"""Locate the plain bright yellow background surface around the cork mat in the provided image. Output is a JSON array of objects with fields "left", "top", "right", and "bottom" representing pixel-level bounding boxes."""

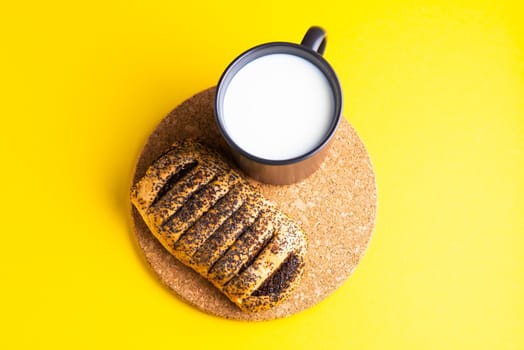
[{"left": 0, "top": 0, "right": 524, "bottom": 349}]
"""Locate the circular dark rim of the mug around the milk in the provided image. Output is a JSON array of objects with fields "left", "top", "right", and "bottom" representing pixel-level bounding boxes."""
[{"left": 214, "top": 41, "right": 343, "bottom": 165}]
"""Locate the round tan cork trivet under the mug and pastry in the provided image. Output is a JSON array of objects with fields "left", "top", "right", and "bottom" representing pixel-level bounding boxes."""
[{"left": 132, "top": 88, "right": 377, "bottom": 321}]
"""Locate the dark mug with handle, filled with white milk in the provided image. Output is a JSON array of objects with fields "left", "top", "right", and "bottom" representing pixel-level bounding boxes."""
[{"left": 215, "top": 27, "right": 342, "bottom": 185}]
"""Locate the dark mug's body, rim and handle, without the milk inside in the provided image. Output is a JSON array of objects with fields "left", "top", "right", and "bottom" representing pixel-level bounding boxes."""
[{"left": 215, "top": 27, "right": 342, "bottom": 185}]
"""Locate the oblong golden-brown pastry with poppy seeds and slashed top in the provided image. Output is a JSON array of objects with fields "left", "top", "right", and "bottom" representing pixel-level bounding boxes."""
[{"left": 131, "top": 140, "right": 306, "bottom": 312}]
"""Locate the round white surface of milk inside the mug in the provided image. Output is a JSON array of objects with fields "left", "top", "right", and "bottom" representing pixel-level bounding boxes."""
[{"left": 223, "top": 54, "right": 335, "bottom": 160}]
